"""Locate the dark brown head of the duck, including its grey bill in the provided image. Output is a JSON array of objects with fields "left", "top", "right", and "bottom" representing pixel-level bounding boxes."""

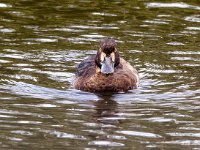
[{"left": 95, "top": 37, "right": 120, "bottom": 75}]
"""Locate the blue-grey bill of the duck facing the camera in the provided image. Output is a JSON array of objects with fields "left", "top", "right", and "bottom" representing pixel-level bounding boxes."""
[{"left": 101, "top": 57, "right": 114, "bottom": 74}]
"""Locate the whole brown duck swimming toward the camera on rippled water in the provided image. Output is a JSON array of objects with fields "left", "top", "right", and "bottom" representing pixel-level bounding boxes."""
[{"left": 73, "top": 37, "right": 139, "bottom": 92}]
